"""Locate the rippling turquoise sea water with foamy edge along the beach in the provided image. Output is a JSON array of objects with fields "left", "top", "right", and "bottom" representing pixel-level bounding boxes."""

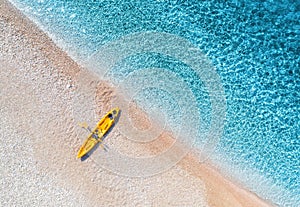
[{"left": 10, "top": 0, "right": 300, "bottom": 206}]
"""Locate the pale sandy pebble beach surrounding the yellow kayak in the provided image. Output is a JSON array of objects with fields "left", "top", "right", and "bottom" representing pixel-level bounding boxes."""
[{"left": 0, "top": 0, "right": 273, "bottom": 207}]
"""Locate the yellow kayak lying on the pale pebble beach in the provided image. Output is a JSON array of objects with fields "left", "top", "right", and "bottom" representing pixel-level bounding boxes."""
[{"left": 77, "top": 108, "right": 120, "bottom": 158}]
